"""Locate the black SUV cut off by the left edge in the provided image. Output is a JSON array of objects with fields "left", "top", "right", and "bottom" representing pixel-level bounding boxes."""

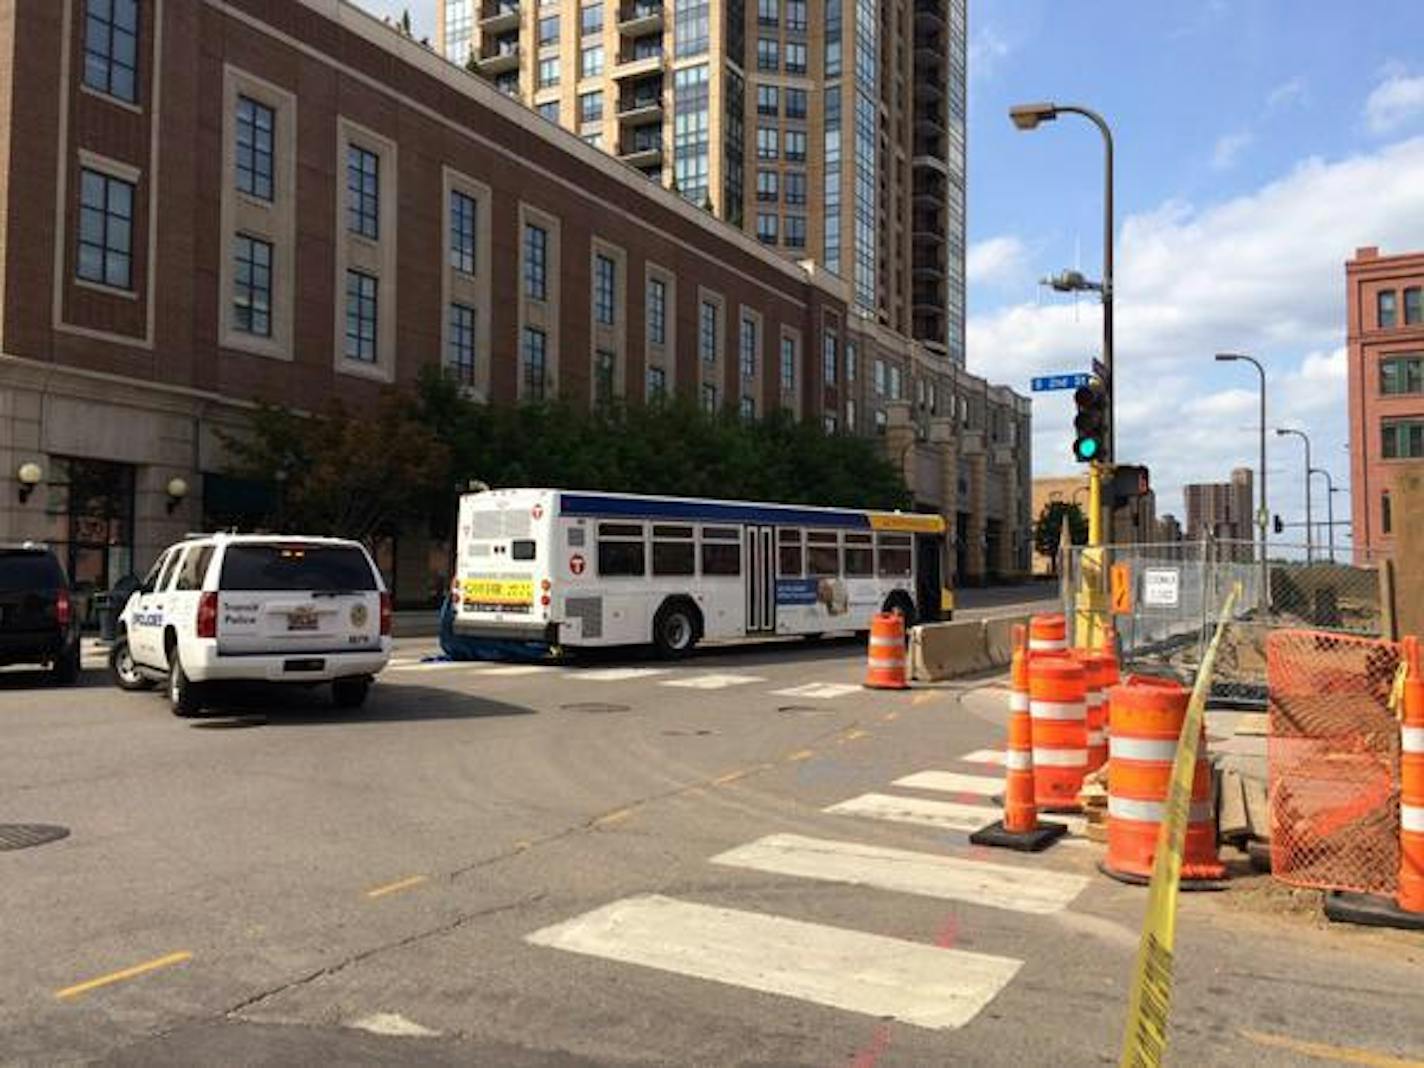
[{"left": 0, "top": 544, "right": 80, "bottom": 684}]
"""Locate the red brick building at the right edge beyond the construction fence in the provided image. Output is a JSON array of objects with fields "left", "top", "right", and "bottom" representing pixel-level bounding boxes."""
[{"left": 1344, "top": 248, "right": 1424, "bottom": 562}]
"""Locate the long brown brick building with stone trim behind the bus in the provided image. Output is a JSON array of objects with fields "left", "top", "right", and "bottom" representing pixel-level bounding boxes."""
[{"left": 0, "top": 0, "right": 1030, "bottom": 601}]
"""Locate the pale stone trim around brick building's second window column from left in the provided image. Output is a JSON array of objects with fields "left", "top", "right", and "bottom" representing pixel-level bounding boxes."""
[{"left": 218, "top": 64, "right": 293, "bottom": 360}]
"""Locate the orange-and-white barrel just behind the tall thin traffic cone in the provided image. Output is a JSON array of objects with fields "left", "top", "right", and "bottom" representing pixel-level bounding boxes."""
[{"left": 1028, "top": 657, "right": 1088, "bottom": 812}]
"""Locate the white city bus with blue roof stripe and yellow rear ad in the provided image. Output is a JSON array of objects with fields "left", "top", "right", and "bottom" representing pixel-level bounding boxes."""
[{"left": 450, "top": 490, "right": 948, "bottom": 656}]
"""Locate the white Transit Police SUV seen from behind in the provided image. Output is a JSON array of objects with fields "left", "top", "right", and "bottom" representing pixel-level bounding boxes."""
[{"left": 110, "top": 534, "right": 390, "bottom": 716}]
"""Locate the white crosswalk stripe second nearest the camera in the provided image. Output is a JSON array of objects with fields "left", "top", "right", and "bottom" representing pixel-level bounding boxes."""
[{"left": 712, "top": 834, "right": 1088, "bottom": 914}]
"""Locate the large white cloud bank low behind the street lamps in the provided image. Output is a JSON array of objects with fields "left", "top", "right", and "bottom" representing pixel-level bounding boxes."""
[{"left": 968, "top": 137, "right": 1424, "bottom": 532}]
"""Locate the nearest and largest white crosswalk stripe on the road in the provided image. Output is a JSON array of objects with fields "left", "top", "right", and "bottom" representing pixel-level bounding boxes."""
[{"left": 525, "top": 894, "right": 1022, "bottom": 1028}]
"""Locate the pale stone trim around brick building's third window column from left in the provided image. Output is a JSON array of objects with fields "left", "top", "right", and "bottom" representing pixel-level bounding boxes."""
[{"left": 332, "top": 112, "right": 395, "bottom": 383}]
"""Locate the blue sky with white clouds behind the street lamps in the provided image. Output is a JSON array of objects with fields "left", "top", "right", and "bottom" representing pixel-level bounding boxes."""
[{"left": 362, "top": 0, "right": 1424, "bottom": 546}]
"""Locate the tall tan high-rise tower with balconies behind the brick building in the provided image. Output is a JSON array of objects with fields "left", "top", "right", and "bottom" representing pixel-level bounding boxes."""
[{"left": 437, "top": 0, "right": 967, "bottom": 365}]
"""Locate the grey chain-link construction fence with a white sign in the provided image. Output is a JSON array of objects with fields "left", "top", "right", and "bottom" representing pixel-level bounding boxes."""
[{"left": 1061, "top": 538, "right": 1384, "bottom": 708}]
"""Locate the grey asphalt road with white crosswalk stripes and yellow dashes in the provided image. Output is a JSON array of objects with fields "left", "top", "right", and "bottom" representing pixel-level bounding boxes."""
[{"left": 0, "top": 641, "right": 1424, "bottom": 1068}]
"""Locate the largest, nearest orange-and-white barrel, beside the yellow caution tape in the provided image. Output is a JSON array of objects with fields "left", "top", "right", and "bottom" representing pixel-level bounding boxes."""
[{"left": 1101, "top": 675, "right": 1226, "bottom": 890}]
